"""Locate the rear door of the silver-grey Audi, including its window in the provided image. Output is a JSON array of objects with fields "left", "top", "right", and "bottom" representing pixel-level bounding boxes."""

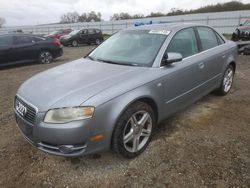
[{"left": 196, "top": 26, "right": 226, "bottom": 92}]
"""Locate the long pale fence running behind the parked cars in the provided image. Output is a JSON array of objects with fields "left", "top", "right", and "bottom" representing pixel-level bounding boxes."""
[{"left": 0, "top": 10, "right": 250, "bottom": 34}]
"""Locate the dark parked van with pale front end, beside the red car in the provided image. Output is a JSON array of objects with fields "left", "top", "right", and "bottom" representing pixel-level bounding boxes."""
[{"left": 60, "top": 29, "right": 103, "bottom": 47}]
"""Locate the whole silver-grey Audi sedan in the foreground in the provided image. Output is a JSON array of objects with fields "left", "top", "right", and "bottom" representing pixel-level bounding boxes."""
[{"left": 14, "top": 23, "right": 238, "bottom": 158}]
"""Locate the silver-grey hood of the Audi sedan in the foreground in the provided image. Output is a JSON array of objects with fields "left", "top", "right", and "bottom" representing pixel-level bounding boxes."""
[{"left": 17, "top": 59, "right": 145, "bottom": 112}]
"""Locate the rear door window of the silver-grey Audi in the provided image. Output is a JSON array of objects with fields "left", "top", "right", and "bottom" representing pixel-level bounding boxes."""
[{"left": 197, "top": 27, "right": 218, "bottom": 51}]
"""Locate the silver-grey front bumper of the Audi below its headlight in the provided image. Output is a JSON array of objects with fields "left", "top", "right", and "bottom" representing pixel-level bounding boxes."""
[{"left": 15, "top": 111, "right": 91, "bottom": 157}]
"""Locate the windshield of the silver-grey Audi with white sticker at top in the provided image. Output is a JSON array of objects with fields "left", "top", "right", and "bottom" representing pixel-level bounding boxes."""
[{"left": 88, "top": 30, "right": 169, "bottom": 66}]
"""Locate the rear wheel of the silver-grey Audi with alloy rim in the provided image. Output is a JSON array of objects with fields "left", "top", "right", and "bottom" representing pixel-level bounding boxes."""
[{"left": 215, "top": 65, "right": 235, "bottom": 96}]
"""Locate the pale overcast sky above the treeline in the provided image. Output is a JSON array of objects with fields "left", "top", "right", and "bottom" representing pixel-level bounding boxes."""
[{"left": 0, "top": 0, "right": 250, "bottom": 26}]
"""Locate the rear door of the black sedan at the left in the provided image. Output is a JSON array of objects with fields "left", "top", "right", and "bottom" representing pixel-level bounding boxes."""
[{"left": 11, "top": 35, "right": 36, "bottom": 61}]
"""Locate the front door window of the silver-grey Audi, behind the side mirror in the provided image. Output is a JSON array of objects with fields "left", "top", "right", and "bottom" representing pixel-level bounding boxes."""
[{"left": 166, "top": 28, "right": 198, "bottom": 58}]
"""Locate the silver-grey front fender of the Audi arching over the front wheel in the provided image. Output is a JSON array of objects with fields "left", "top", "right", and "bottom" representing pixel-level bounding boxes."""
[{"left": 83, "top": 80, "right": 164, "bottom": 146}]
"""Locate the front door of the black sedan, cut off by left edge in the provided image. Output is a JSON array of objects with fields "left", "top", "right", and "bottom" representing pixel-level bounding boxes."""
[{"left": 0, "top": 35, "right": 13, "bottom": 64}]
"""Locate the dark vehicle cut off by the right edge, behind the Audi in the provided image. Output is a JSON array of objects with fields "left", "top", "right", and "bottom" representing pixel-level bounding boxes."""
[{"left": 232, "top": 18, "right": 250, "bottom": 41}]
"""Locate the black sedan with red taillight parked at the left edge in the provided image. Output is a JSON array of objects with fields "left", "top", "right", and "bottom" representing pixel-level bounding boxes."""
[{"left": 0, "top": 34, "right": 63, "bottom": 66}]
